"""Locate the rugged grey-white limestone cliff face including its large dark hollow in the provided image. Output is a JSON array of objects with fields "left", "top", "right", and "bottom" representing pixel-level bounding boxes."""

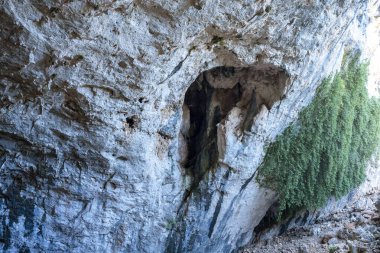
[{"left": 0, "top": 0, "right": 376, "bottom": 252}]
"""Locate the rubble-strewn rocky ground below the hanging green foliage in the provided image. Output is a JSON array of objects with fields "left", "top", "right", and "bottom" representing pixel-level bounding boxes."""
[{"left": 242, "top": 192, "right": 380, "bottom": 253}]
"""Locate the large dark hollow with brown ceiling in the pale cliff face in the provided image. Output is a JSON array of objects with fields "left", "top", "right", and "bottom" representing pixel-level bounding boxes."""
[{"left": 179, "top": 64, "right": 289, "bottom": 187}]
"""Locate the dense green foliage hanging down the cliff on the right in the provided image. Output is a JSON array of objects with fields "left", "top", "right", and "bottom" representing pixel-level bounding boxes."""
[{"left": 258, "top": 54, "right": 380, "bottom": 217}]
